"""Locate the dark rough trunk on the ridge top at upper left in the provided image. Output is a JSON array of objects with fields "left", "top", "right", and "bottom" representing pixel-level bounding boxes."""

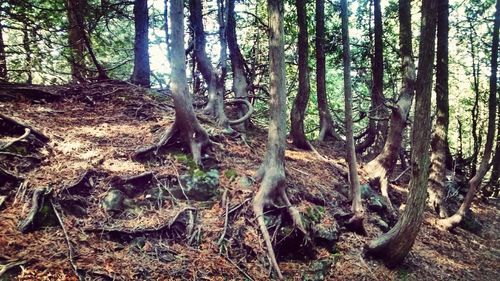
[{"left": 66, "top": 0, "right": 87, "bottom": 82}]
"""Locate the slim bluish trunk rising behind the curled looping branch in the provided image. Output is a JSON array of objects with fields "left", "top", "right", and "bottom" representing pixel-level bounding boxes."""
[{"left": 226, "top": 0, "right": 248, "bottom": 131}]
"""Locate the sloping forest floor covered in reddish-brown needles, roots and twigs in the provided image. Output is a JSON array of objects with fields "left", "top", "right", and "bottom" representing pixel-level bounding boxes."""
[{"left": 0, "top": 82, "right": 500, "bottom": 280}]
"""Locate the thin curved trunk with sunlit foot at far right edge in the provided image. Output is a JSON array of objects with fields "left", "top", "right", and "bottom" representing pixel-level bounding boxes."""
[{"left": 438, "top": 0, "right": 500, "bottom": 229}]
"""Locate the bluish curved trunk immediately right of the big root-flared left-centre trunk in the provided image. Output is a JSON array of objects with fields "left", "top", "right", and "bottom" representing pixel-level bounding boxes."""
[{"left": 189, "top": 0, "right": 230, "bottom": 128}]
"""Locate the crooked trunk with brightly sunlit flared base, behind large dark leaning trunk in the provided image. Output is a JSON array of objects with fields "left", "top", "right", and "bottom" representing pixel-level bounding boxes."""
[{"left": 365, "top": 1, "right": 415, "bottom": 210}]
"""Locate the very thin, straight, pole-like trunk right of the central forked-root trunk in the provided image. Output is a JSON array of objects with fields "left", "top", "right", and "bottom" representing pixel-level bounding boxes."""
[{"left": 340, "top": 0, "right": 364, "bottom": 232}]
